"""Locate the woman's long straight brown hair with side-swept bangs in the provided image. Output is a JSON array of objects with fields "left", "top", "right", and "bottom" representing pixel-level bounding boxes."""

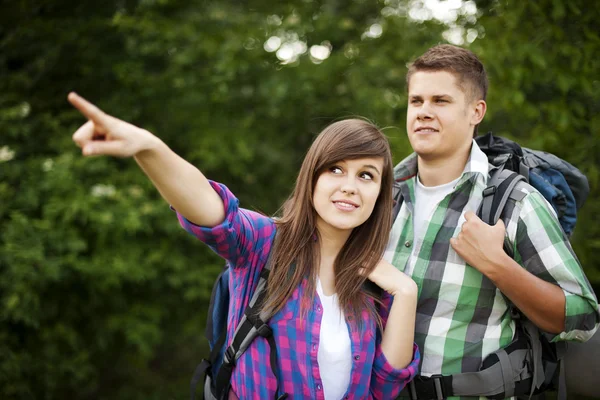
[{"left": 264, "top": 119, "right": 393, "bottom": 321}]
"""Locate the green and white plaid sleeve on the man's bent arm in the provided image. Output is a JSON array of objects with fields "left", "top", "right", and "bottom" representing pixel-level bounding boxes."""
[{"left": 514, "top": 192, "right": 600, "bottom": 341}]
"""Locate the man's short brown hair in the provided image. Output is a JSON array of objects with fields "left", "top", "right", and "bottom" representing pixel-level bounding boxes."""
[{"left": 406, "top": 44, "right": 488, "bottom": 102}]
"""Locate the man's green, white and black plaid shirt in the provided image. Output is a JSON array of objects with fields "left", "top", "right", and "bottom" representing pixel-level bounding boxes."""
[{"left": 385, "top": 142, "right": 600, "bottom": 399}]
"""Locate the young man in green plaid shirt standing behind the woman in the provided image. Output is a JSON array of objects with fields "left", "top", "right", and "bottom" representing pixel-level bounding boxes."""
[{"left": 386, "top": 45, "right": 600, "bottom": 399}]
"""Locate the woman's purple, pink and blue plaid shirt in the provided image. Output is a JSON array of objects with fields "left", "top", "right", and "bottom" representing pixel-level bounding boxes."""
[{"left": 178, "top": 182, "right": 419, "bottom": 399}]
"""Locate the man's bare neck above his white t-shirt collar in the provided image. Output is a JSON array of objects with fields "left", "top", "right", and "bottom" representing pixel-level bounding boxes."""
[{"left": 417, "top": 146, "right": 471, "bottom": 186}]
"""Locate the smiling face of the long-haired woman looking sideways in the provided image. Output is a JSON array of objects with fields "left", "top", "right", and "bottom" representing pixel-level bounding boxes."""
[{"left": 313, "top": 157, "right": 383, "bottom": 238}]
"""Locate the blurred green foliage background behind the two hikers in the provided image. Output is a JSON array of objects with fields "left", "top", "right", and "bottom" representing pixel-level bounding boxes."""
[{"left": 0, "top": 0, "right": 600, "bottom": 399}]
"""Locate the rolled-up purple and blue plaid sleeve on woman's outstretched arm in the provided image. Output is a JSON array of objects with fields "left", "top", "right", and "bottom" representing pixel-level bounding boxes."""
[{"left": 175, "top": 181, "right": 275, "bottom": 267}]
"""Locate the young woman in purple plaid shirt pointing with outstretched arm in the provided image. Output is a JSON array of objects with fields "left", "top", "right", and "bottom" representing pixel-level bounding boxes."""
[{"left": 68, "top": 93, "right": 419, "bottom": 399}]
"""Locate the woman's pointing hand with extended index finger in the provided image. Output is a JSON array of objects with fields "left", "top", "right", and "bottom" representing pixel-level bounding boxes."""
[{"left": 68, "top": 92, "right": 160, "bottom": 157}]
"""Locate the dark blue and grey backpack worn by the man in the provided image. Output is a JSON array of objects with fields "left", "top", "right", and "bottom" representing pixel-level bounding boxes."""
[{"left": 475, "top": 132, "right": 600, "bottom": 398}]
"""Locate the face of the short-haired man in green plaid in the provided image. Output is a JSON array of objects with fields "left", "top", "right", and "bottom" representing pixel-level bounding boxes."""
[{"left": 406, "top": 71, "right": 485, "bottom": 162}]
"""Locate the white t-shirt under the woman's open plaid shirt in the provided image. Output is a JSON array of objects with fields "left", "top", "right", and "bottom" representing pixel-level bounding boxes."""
[{"left": 317, "top": 279, "right": 352, "bottom": 400}]
